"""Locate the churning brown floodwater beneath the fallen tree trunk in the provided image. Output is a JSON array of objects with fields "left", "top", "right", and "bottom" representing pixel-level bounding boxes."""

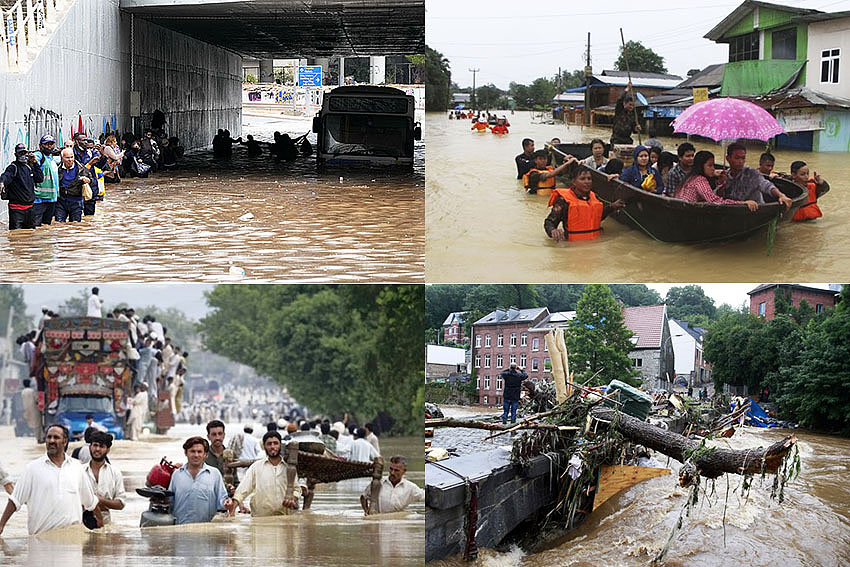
[{"left": 432, "top": 429, "right": 850, "bottom": 567}]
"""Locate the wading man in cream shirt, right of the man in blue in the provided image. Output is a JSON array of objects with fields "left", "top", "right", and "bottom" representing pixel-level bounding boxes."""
[{"left": 230, "top": 431, "right": 300, "bottom": 517}]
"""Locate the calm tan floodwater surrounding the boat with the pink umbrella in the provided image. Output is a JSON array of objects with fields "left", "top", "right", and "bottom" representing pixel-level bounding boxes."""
[{"left": 425, "top": 112, "right": 850, "bottom": 283}]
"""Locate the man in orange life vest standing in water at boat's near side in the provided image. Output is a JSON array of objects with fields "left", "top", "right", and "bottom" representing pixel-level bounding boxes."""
[{"left": 543, "top": 166, "right": 626, "bottom": 242}]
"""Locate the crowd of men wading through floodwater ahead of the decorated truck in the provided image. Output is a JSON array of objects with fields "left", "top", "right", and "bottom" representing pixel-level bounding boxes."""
[{"left": 0, "top": 412, "right": 425, "bottom": 536}]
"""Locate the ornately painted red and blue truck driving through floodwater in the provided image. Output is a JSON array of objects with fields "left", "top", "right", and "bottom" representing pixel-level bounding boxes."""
[{"left": 37, "top": 317, "right": 132, "bottom": 439}]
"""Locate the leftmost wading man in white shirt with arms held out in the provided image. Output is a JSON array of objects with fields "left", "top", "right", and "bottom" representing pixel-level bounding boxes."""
[{"left": 0, "top": 425, "right": 102, "bottom": 535}]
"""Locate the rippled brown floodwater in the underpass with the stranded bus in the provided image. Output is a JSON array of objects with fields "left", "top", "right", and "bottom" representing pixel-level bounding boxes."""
[{"left": 0, "top": 115, "right": 425, "bottom": 283}]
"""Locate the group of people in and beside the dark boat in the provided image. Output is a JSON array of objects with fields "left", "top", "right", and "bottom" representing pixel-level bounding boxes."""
[{"left": 515, "top": 133, "right": 829, "bottom": 241}]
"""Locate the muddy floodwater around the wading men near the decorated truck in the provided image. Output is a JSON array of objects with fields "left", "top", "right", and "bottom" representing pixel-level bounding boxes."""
[{"left": 0, "top": 424, "right": 425, "bottom": 567}]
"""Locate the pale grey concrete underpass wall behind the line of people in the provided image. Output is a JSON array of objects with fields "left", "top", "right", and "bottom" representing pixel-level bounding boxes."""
[{"left": 0, "top": 0, "right": 242, "bottom": 168}]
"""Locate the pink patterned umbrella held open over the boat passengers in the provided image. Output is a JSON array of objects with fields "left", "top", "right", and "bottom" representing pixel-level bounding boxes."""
[{"left": 673, "top": 97, "right": 785, "bottom": 142}]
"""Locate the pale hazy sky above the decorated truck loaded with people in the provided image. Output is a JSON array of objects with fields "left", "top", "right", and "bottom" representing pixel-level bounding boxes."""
[{"left": 22, "top": 284, "right": 215, "bottom": 320}]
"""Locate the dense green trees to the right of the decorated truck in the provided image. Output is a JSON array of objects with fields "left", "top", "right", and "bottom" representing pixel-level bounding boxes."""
[{"left": 201, "top": 285, "right": 425, "bottom": 433}]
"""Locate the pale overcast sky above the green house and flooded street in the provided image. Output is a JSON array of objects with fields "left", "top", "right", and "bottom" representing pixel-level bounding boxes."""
[{"left": 425, "top": 0, "right": 850, "bottom": 89}]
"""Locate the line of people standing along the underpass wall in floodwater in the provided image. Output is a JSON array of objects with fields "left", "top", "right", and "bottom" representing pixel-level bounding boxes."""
[{"left": 0, "top": 127, "right": 183, "bottom": 230}]
